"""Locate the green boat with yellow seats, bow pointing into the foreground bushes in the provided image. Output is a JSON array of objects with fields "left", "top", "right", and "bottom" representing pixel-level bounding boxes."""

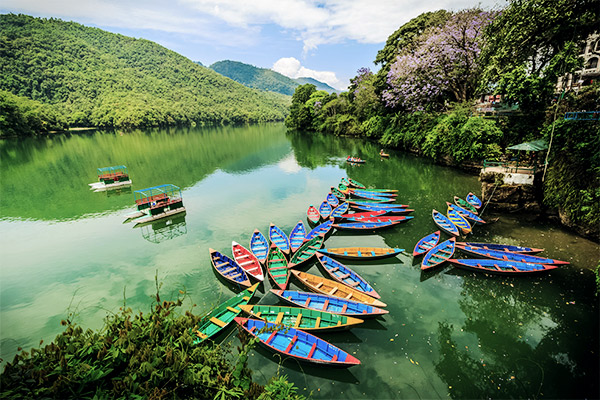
[{"left": 192, "top": 283, "right": 259, "bottom": 344}]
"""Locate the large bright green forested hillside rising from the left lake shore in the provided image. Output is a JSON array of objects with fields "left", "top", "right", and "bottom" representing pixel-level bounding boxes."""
[{"left": 0, "top": 14, "right": 289, "bottom": 133}]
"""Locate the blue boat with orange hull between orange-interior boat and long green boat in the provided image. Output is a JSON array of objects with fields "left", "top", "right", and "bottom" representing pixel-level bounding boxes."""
[{"left": 271, "top": 289, "right": 389, "bottom": 318}]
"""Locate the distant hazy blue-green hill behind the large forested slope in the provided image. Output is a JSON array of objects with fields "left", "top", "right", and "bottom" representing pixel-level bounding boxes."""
[{"left": 210, "top": 60, "right": 338, "bottom": 96}]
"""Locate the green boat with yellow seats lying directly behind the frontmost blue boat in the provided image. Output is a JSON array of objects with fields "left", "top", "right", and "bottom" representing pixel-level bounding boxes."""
[{"left": 240, "top": 304, "right": 364, "bottom": 332}]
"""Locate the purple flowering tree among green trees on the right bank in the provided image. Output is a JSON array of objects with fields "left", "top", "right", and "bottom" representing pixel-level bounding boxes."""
[{"left": 382, "top": 9, "right": 495, "bottom": 111}]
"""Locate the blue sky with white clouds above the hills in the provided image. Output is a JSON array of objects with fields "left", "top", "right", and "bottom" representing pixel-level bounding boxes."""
[{"left": 0, "top": 0, "right": 506, "bottom": 90}]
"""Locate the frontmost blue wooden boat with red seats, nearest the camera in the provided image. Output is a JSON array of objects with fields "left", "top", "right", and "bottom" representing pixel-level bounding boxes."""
[{"left": 235, "top": 317, "right": 360, "bottom": 367}]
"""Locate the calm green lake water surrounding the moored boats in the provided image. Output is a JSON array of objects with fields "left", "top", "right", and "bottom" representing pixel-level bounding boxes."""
[{"left": 0, "top": 124, "right": 600, "bottom": 399}]
